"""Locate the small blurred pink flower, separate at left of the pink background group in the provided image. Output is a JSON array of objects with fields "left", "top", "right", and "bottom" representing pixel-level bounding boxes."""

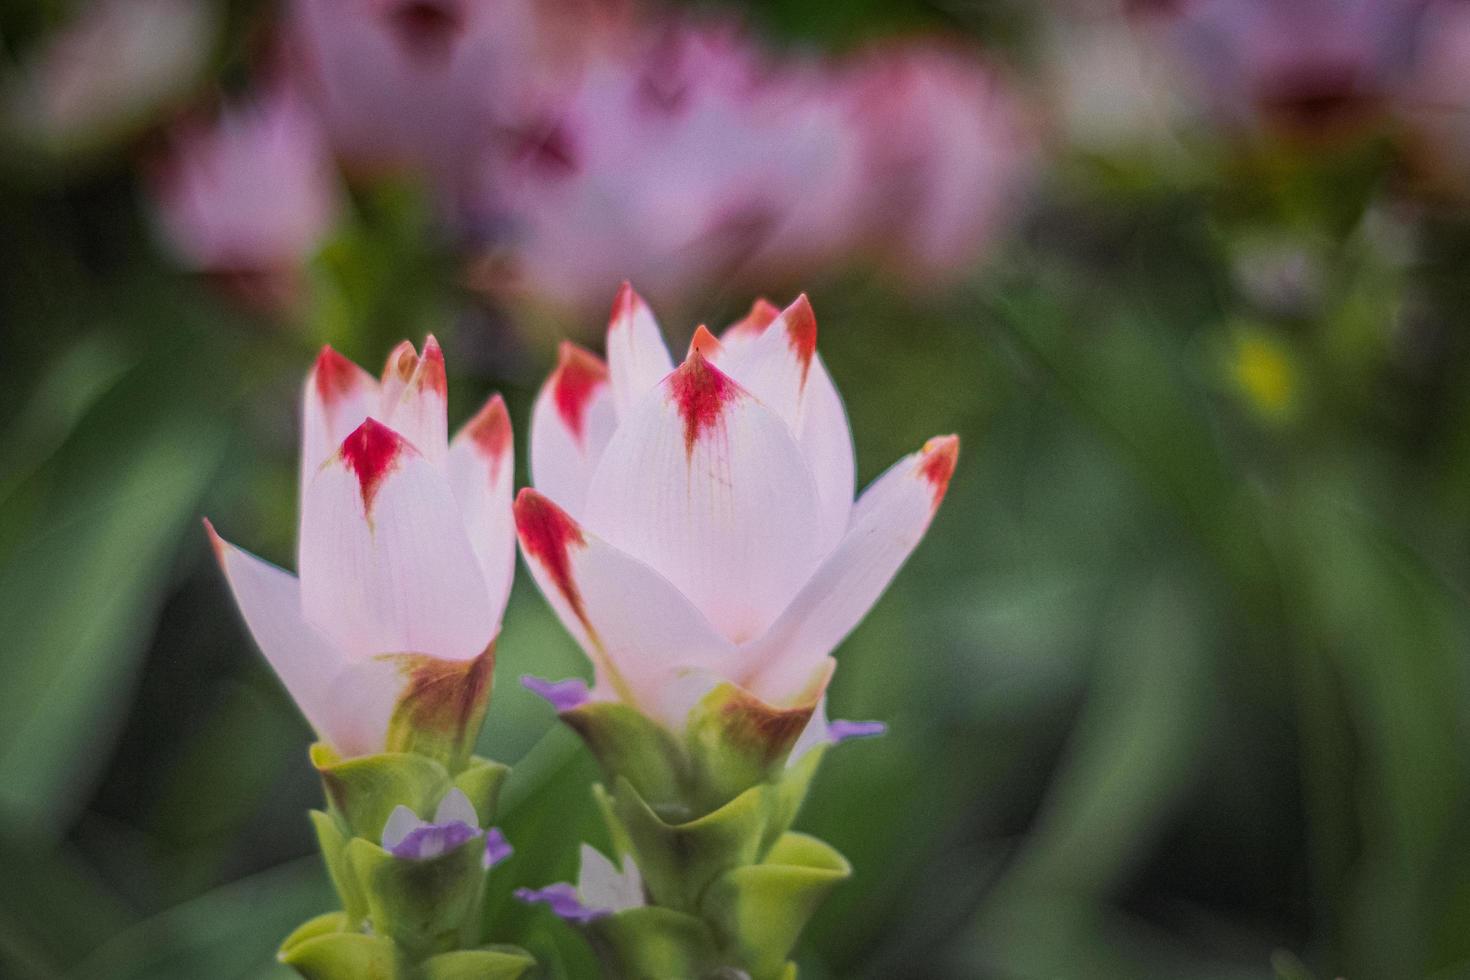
[{"left": 153, "top": 87, "right": 343, "bottom": 307}]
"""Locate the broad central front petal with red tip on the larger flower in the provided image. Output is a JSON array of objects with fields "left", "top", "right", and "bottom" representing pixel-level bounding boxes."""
[{"left": 587, "top": 353, "right": 819, "bottom": 642}]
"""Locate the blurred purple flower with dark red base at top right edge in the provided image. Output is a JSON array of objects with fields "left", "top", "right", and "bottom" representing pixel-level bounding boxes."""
[{"left": 1135, "top": 0, "right": 1426, "bottom": 138}]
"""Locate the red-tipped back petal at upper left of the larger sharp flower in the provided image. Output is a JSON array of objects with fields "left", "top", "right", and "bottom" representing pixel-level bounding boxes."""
[{"left": 531, "top": 344, "right": 617, "bottom": 519}]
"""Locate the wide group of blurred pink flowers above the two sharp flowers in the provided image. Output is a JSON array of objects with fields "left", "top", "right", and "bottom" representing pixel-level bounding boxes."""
[{"left": 143, "top": 0, "right": 1033, "bottom": 311}]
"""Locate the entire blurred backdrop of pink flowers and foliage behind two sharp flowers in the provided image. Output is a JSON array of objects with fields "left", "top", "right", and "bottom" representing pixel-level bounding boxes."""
[{"left": 0, "top": 0, "right": 1470, "bottom": 980}]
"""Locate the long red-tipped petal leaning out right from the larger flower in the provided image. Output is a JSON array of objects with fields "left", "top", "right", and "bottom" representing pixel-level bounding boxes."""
[{"left": 742, "top": 435, "right": 960, "bottom": 701}]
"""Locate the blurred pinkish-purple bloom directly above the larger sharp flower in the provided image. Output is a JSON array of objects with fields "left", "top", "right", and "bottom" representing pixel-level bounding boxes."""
[{"left": 482, "top": 18, "right": 856, "bottom": 309}]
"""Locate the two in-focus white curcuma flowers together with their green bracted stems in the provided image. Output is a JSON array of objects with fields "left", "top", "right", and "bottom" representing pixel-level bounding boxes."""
[{"left": 206, "top": 284, "right": 958, "bottom": 977}]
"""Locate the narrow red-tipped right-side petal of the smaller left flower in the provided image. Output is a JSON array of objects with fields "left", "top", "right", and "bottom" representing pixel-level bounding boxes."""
[{"left": 447, "top": 395, "right": 516, "bottom": 621}]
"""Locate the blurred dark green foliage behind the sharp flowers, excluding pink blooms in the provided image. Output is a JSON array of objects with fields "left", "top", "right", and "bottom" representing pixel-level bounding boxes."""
[{"left": 0, "top": 0, "right": 1470, "bottom": 980}]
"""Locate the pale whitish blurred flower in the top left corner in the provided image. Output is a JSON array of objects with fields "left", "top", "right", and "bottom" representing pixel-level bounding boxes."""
[{"left": 3, "top": 0, "right": 219, "bottom": 151}]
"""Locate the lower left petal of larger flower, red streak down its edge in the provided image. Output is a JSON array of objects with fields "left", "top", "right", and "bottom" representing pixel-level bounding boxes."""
[{"left": 516, "top": 488, "right": 735, "bottom": 713}]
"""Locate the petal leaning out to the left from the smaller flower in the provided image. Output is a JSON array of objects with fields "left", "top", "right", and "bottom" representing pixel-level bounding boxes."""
[{"left": 204, "top": 520, "right": 353, "bottom": 751}]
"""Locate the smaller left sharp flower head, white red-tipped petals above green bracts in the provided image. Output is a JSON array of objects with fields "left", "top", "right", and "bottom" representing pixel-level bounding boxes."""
[{"left": 206, "top": 336, "right": 515, "bottom": 758}]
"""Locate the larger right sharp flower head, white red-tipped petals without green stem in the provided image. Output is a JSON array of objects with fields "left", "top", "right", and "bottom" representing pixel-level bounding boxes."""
[{"left": 515, "top": 285, "right": 958, "bottom": 732}]
